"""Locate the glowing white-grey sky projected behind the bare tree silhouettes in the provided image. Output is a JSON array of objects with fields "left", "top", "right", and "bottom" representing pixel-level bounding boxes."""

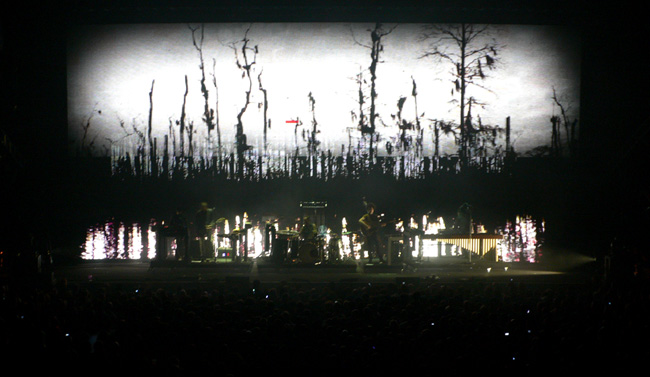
[{"left": 68, "top": 23, "right": 580, "bottom": 159}]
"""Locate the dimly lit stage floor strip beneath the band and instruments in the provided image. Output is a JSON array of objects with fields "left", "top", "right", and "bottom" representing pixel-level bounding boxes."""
[{"left": 46, "top": 257, "right": 600, "bottom": 287}]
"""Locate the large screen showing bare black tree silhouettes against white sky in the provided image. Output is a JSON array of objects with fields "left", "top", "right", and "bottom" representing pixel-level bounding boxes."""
[{"left": 67, "top": 23, "right": 581, "bottom": 176}]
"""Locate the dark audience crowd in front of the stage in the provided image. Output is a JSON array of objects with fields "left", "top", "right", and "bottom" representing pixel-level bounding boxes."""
[{"left": 0, "top": 266, "right": 650, "bottom": 376}]
